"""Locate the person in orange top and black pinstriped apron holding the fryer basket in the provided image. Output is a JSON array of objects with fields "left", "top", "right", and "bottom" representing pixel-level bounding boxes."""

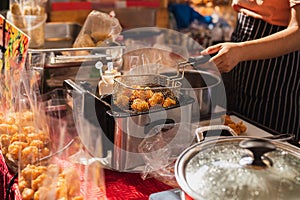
[{"left": 202, "top": 0, "right": 300, "bottom": 141}]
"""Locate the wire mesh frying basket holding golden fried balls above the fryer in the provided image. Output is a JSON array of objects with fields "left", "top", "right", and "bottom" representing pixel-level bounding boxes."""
[{"left": 113, "top": 74, "right": 181, "bottom": 113}]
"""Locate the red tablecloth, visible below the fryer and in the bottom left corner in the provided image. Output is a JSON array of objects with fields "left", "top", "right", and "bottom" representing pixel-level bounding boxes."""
[{"left": 0, "top": 151, "right": 172, "bottom": 200}]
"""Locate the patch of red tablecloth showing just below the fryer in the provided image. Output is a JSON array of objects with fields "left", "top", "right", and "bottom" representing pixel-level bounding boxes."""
[{"left": 105, "top": 170, "right": 172, "bottom": 200}]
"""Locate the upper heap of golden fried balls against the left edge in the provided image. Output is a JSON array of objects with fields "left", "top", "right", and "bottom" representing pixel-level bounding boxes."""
[{"left": 0, "top": 111, "right": 50, "bottom": 169}]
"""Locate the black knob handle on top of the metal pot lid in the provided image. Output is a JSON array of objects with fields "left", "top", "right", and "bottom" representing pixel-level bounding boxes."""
[{"left": 239, "top": 138, "right": 276, "bottom": 167}]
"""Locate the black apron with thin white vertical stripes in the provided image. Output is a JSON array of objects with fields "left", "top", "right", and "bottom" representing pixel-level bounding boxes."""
[{"left": 226, "top": 13, "right": 300, "bottom": 141}]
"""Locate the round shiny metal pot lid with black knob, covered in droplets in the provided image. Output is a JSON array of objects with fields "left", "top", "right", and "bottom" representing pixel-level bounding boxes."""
[{"left": 175, "top": 137, "right": 300, "bottom": 200}]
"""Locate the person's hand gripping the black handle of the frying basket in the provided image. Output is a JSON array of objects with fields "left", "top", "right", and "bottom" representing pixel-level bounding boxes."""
[{"left": 201, "top": 42, "right": 243, "bottom": 73}]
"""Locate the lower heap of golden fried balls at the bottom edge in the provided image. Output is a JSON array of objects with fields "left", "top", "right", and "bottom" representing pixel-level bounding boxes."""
[{"left": 19, "top": 164, "right": 83, "bottom": 200}]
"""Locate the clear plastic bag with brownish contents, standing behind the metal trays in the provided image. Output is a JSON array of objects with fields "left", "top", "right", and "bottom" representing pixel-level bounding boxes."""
[{"left": 73, "top": 10, "right": 122, "bottom": 48}]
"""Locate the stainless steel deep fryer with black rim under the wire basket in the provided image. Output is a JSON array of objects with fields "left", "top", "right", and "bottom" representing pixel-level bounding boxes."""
[{"left": 65, "top": 80, "right": 194, "bottom": 171}]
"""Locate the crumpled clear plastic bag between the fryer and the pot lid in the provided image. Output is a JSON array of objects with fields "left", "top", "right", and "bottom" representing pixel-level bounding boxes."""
[{"left": 139, "top": 123, "right": 196, "bottom": 188}]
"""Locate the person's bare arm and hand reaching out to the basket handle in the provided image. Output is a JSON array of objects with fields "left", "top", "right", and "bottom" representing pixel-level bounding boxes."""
[{"left": 201, "top": 4, "right": 300, "bottom": 72}]
